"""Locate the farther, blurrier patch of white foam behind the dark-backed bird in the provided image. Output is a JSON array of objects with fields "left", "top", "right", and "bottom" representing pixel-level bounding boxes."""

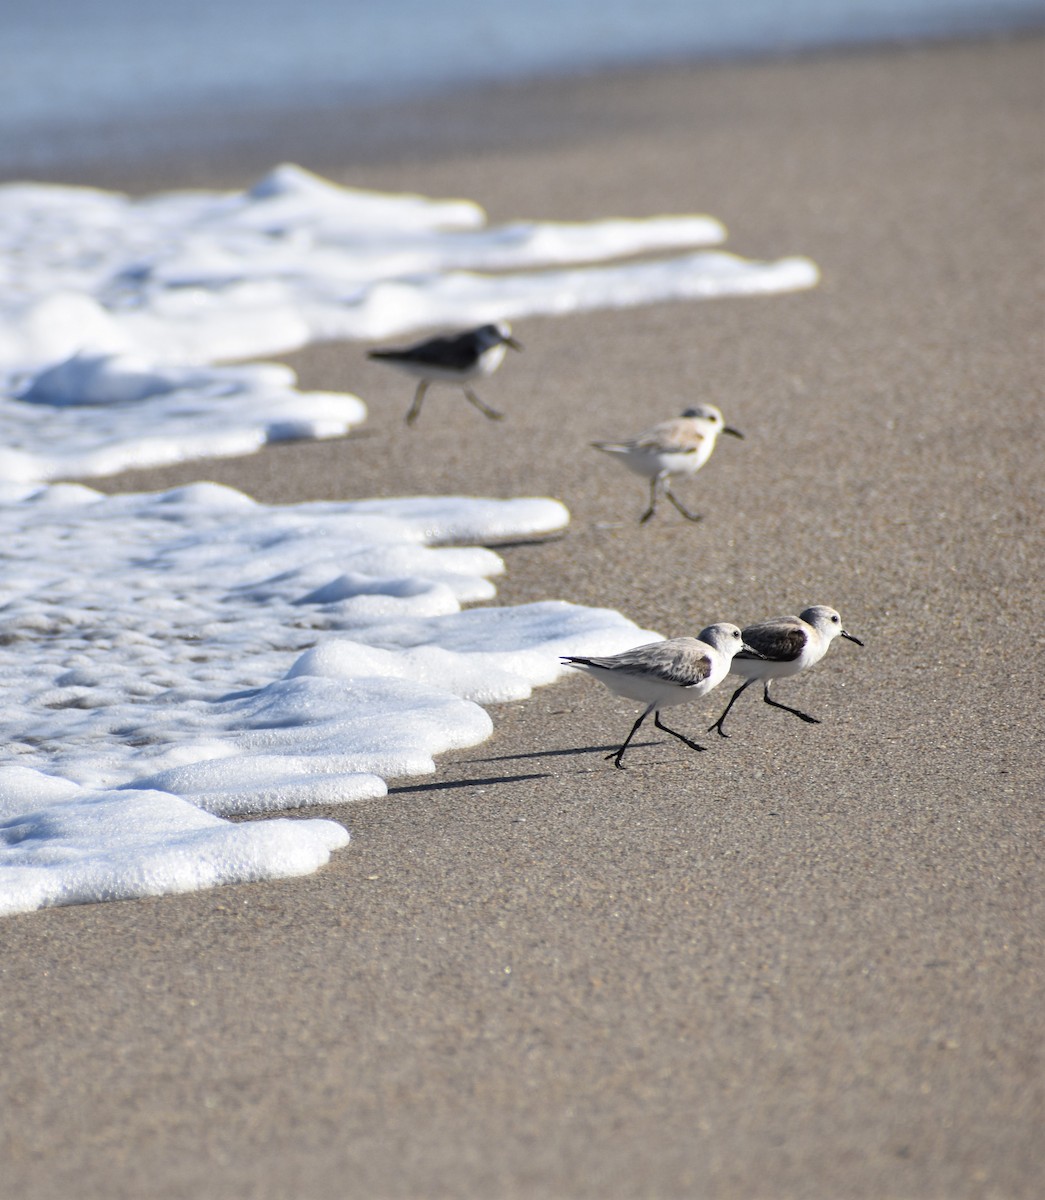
[{"left": 0, "top": 166, "right": 817, "bottom": 482}]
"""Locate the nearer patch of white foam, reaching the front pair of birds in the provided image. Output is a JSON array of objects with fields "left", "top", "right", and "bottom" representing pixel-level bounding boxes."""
[{"left": 0, "top": 484, "right": 656, "bottom": 913}]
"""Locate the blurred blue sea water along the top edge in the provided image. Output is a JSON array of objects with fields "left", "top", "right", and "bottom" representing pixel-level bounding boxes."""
[{"left": 0, "top": 0, "right": 1045, "bottom": 169}]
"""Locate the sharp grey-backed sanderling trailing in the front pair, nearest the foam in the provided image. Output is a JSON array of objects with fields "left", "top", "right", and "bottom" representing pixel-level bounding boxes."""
[{"left": 563, "top": 622, "right": 758, "bottom": 770}]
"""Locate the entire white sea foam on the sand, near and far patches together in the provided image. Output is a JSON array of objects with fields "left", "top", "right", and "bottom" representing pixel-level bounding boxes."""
[{"left": 0, "top": 164, "right": 818, "bottom": 913}]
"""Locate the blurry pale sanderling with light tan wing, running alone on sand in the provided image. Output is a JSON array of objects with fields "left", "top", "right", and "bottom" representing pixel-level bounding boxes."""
[{"left": 591, "top": 404, "right": 744, "bottom": 524}]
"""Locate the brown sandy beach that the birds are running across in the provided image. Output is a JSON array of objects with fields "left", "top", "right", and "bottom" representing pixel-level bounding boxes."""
[{"left": 0, "top": 38, "right": 1045, "bottom": 1200}]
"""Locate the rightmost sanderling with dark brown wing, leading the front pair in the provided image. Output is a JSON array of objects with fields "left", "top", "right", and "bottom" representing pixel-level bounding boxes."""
[{"left": 708, "top": 604, "right": 864, "bottom": 738}]
